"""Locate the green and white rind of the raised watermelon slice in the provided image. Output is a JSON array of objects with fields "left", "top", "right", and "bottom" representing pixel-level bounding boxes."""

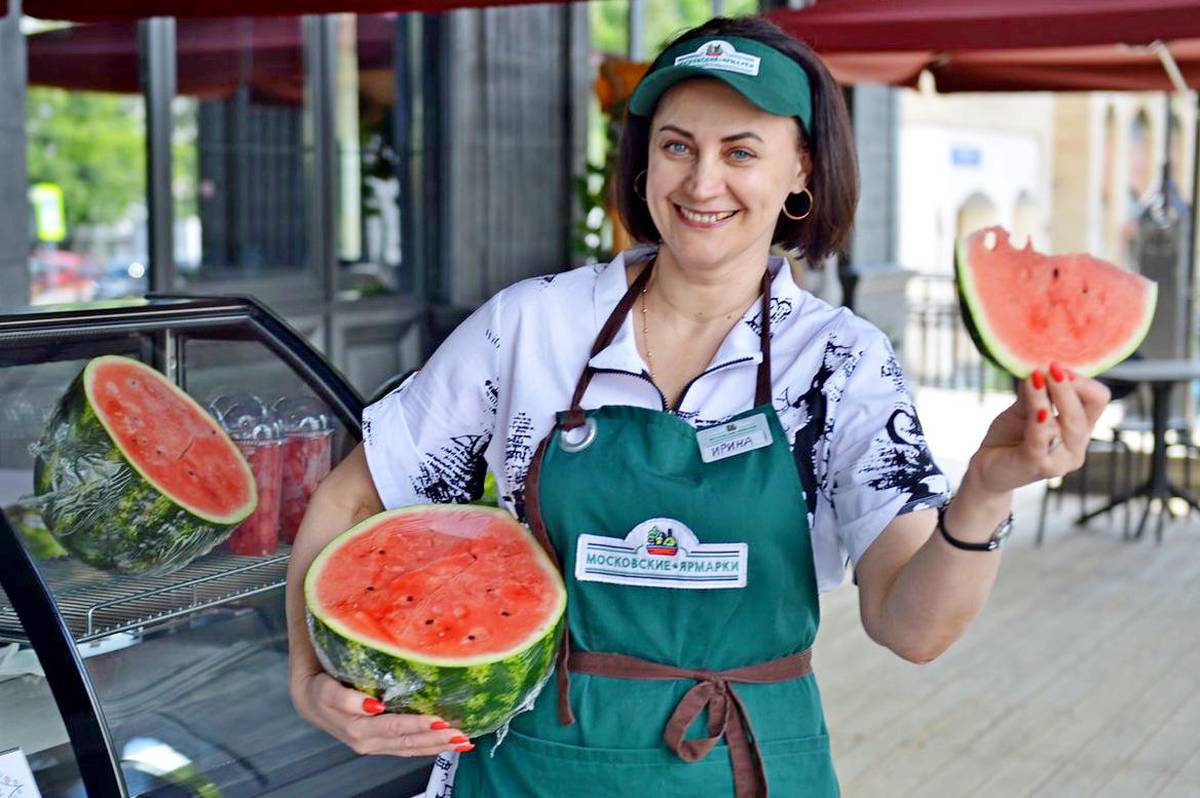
[{"left": 954, "top": 230, "right": 1158, "bottom": 379}]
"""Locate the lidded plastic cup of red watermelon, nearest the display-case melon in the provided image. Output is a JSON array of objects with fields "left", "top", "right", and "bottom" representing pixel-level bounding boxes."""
[{"left": 209, "top": 394, "right": 283, "bottom": 556}]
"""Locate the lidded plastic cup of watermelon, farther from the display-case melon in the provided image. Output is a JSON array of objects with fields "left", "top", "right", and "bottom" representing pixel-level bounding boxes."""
[{"left": 271, "top": 396, "right": 334, "bottom": 544}]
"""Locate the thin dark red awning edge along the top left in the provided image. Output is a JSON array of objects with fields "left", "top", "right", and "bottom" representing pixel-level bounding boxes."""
[{"left": 23, "top": 0, "right": 568, "bottom": 22}]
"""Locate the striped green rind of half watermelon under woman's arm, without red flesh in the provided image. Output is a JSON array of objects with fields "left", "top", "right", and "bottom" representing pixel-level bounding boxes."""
[{"left": 305, "top": 504, "right": 566, "bottom": 737}]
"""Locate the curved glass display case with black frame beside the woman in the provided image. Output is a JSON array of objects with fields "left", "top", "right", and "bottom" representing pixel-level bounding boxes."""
[{"left": 0, "top": 296, "right": 428, "bottom": 798}]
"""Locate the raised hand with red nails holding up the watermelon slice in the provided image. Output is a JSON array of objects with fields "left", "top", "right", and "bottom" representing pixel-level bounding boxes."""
[{"left": 971, "top": 364, "right": 1109, "bottom": 493}]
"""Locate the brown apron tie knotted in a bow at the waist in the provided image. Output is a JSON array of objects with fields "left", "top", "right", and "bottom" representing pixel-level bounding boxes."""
[{"left": 559, "top": 649, "right": 812, "bottom": 798}]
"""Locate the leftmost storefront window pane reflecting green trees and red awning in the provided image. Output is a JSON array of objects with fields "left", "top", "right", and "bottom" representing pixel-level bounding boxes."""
[{"left": 23, "top": 18, "right": 148, "bottom": 305}]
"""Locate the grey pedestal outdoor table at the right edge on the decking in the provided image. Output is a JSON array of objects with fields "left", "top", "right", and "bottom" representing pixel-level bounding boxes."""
[{"left": 1075, "top": 359, "right": 1200, "bottom": 542}]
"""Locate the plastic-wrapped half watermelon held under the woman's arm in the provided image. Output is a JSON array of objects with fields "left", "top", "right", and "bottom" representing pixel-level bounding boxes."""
[{"left": 305, "top": 505, "right": 566, "bottom": 736}]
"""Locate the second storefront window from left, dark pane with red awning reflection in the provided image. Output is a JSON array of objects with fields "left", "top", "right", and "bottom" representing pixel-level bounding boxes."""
[{"left": 172, "top": 17, "right": 311, "bottom": 286}]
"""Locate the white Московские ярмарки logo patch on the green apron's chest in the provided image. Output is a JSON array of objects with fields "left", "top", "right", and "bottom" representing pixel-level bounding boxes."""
[{"left": 575, "top": 518, "right": 748, "bottom": 590}]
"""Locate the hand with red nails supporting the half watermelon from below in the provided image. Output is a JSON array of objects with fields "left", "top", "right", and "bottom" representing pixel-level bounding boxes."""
[{"left": 290, "top": 671, "right": 475, "bottom": 756}]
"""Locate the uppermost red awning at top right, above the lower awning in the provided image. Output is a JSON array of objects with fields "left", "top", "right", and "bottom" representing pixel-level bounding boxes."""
[{"left": 763, "top": 0, "right": 1200, "bottom": 54}]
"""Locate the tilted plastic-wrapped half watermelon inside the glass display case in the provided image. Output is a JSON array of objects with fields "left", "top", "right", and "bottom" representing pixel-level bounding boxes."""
[{"left": 34, "top": 355, "right": 258, "bottom": 574}]
